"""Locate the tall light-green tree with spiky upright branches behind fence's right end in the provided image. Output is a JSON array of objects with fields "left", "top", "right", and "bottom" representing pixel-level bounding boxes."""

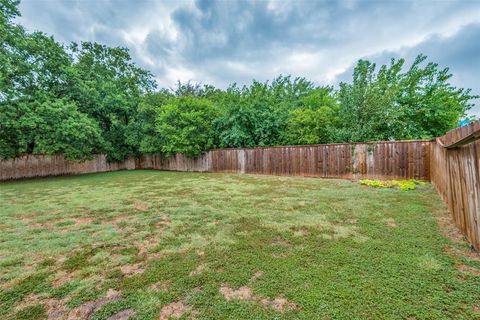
[{"left": 338, "top": 55, "right": 476, "bottom": 141}]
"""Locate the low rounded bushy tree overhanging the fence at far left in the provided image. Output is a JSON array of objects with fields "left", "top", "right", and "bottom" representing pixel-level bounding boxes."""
[{"left": 0, "top": 99, "right": 103, "bottom": 160}]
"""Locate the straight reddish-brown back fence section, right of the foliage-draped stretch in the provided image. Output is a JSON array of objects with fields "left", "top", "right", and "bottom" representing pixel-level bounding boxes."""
[{"left": 197, "top": 141, "right": 431, "bottom": 180}]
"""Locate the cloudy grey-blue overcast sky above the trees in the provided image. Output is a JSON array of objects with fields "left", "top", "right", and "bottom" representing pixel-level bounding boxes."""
[{"left": 18, "top": 0, "right": 480, "bottom": 116}]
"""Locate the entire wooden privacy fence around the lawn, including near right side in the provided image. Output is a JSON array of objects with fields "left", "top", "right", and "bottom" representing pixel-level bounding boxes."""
[{"left": 0, "top": 121, "right": 480, "bottom": 250}]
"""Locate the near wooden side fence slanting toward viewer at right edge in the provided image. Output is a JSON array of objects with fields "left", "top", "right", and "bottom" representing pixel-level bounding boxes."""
[{"left": 430, "top": 121, "right": 480, "bottom": 250}]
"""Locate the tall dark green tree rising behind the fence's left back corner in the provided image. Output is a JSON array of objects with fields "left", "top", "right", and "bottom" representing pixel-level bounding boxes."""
[{"left": 66, "top": 42, "right": 156, "bottom": 160}]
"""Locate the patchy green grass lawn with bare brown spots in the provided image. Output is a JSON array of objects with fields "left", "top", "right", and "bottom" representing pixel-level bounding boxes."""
[{"left": 0, "top": 170, "right": 480, "bottom": 320}]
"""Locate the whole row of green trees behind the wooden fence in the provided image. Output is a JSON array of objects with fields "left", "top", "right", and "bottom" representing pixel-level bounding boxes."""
[{"left": 0, "top": 0, "right": 477, "bottom": 161}]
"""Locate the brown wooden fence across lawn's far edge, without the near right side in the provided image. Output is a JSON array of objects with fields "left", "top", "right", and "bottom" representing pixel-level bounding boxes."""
[{"left": 0, "top": 141, "right": 432, "bottom": 181}]
